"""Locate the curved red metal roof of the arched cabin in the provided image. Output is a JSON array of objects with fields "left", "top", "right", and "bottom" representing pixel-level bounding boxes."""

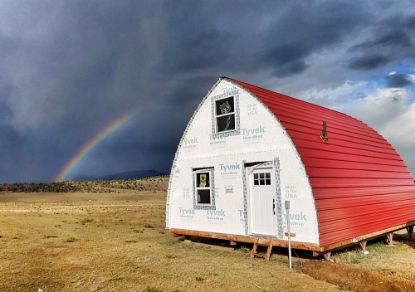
[{"left": 226, "top": 78, "right": 415, "bottom": 246}]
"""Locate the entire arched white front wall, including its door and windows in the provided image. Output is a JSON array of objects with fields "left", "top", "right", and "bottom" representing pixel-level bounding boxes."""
[{"left": 166, "top": 78, "right": 319, "bottom": 245}]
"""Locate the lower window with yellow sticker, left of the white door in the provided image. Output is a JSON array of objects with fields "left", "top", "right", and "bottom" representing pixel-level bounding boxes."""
[{"left": 193, "top": 168, "right": 215, "bottom": 209}]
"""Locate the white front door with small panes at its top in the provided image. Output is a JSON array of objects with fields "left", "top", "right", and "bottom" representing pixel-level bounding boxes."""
[{"left": 247, "top": 163, "right": 278, "bottom": 236}]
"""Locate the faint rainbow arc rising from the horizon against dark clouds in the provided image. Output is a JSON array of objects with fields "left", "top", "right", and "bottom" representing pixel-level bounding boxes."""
[{"left": 53, "top": 112, "right": 134, "bottom": 182}]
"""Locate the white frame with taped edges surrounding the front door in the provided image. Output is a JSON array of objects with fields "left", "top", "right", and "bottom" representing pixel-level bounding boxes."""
[{"left": 242, "top": 157, "right": 283, "bottom": 239}]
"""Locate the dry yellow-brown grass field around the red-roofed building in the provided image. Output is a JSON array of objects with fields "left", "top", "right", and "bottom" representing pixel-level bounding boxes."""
[{"left": 0, "top": 178, "right": 415, "bottom": 292}]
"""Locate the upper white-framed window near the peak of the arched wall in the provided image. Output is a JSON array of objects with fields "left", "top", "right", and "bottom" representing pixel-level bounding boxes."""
[{"left": 215, "top": 96, "right": 235, "bottom": 133}]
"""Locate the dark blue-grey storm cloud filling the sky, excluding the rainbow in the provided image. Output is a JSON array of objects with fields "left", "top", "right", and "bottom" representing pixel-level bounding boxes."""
[{"left": 0, "top": 1, "right": 414, "bottom": 181}]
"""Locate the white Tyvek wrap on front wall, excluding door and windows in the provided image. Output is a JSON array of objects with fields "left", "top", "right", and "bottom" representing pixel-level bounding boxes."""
[{"left": 166, "top": 79, "right": 318, "bottom": 244}]
